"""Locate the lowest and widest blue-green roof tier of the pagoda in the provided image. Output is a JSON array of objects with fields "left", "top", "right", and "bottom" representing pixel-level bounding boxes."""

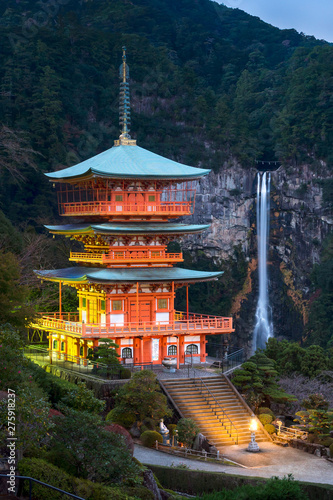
[{"left": 34, "top": 267, "right": 223, "bottom": 284}]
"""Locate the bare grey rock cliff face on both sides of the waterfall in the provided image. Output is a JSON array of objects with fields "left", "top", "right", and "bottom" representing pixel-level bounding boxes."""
[{"left": 182, "top": 163, "right": 333, "bottom": 345}]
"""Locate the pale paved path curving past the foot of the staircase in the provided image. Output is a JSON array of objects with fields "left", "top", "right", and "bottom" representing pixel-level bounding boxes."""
[{"left": 134, "top": 443, "right": 333, "bottom": 485}]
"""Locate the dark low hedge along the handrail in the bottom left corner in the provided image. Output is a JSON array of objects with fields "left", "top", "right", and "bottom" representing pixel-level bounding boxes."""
[{"left": 18, "top": 458, "right": 136, "bottom": 500}]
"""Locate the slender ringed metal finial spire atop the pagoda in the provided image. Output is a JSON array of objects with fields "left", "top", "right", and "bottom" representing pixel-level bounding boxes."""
[{"left": 115, "top": 46, "right": 136, "bottom": 146}]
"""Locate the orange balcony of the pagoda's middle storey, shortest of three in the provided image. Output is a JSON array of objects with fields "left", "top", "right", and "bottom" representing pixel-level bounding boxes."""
[{"left": 69, "top": 248, "right": 184, "bottom": 266}]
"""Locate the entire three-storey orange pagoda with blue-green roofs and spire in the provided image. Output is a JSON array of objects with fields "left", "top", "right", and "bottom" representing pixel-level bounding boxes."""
[{"left": 35, "top": 49, "right": 233, "bottom": 367}]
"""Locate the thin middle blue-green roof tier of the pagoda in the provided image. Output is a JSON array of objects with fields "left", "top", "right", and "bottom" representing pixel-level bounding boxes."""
[{"left": 45, "top": 222, "right": 210, "bottom": 235}]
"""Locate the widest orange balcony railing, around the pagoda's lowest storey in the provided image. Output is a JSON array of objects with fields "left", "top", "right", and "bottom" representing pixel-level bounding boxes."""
[{"left": 30, "top": 311, "right": 234, "bottom": 339}]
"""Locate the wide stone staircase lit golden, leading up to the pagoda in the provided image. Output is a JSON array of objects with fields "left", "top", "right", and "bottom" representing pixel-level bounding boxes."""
[{"left": 160, "top": 375, "right": 270, "bottom": 449}]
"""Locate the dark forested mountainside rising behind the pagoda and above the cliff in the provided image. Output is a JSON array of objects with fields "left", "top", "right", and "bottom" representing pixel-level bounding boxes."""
[{"left": 0, "top": 0, "right": 333, "bottom": 348}]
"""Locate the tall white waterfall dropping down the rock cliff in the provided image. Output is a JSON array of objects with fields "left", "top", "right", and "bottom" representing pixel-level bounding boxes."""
[{"left": 252, "top": 172, "right": 273, "bottom": 352}]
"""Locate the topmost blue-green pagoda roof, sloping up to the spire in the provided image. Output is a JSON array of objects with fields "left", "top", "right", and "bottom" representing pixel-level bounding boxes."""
[{"left": 45, "top": 145, "right": 210, "bottom": 182}]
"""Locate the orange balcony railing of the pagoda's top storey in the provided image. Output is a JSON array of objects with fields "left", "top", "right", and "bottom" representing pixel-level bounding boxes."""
[{"left": 59, "top": 201, "right": 193, "bottom": 217}]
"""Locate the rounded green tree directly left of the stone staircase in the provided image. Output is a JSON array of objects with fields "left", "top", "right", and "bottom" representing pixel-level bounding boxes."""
[{"left": 115, "top": 370, "right": 172, "bottom": 424}]
